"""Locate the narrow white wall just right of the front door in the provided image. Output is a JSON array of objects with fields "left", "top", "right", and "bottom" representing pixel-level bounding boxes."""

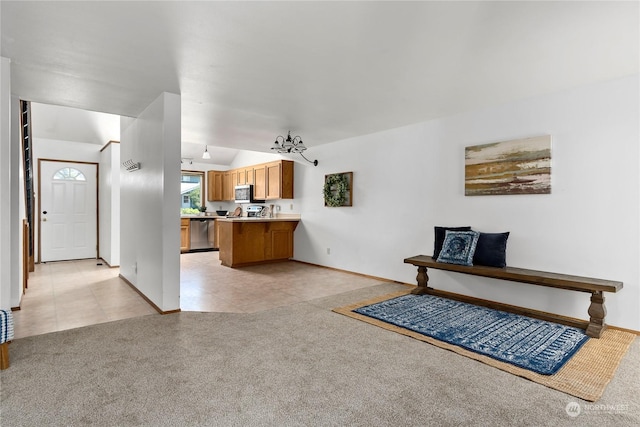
[{"left": 98, "top": 142, "right": 121, "bottom": 267}]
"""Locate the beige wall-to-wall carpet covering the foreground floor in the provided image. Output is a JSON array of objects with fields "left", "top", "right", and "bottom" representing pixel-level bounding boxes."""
[{"left": 0, "top": 284, "right": 640, "bottom": 427}]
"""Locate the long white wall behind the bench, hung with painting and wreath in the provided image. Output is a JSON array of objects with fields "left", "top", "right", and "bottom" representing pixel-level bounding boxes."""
[{"left": 295, "top": 75, "right": 640, "bottom": 330}]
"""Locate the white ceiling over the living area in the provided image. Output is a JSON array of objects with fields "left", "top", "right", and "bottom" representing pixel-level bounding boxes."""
[{"left": 0, "top": 1, "right": 640, "bottom": 163}]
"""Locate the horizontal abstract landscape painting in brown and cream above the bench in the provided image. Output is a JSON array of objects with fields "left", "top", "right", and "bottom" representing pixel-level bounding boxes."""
[{"left": 464, "top": 135, "right": 551, "bottom": 196}]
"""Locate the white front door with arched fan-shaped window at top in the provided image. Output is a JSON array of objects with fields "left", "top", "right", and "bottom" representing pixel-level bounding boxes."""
[{"left": 40, "top": 160, "right": 98, "bottom": 262}]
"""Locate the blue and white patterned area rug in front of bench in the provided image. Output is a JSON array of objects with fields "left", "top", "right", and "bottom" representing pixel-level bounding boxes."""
[{"left": 353, "top": 294, "right": 589, "bottom": 375}]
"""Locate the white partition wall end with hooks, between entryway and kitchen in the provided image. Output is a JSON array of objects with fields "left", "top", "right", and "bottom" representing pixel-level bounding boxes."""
[{"left": 120, "top": 93, "right": 180, "bottom": 311}]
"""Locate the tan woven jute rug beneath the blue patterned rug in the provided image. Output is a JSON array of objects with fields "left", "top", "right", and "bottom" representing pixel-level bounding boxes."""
[{"left": 333, "top": 291, "right": 636, "bottom": 402}]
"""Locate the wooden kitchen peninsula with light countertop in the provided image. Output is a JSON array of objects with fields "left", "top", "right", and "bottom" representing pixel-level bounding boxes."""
[{"left": 216, "top": 217, "right": 300, "bottom": 267}]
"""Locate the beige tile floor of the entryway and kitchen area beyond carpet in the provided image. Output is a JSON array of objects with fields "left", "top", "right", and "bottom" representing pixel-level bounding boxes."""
[{"left": 13, "top": 252, "right": 384, "bottom": 338}]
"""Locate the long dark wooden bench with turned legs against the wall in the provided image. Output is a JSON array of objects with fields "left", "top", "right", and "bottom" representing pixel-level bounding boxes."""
[{"left": 404, "top": 255, "right": 622, "bottom": 338}]
